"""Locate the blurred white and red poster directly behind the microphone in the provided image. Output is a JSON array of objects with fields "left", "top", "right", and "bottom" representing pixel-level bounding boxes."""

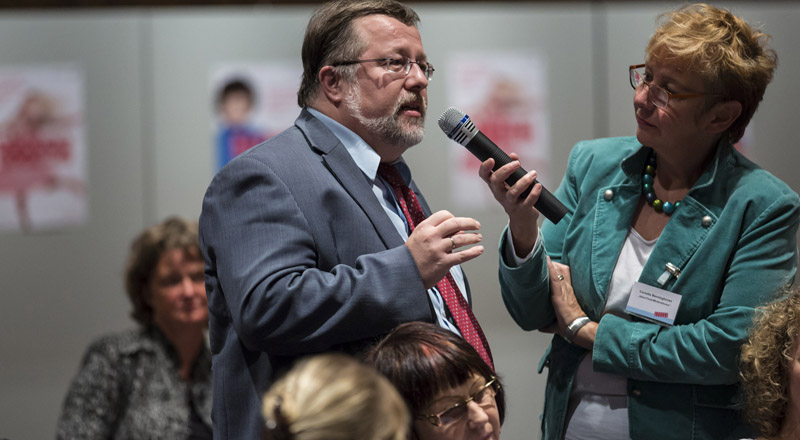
[{"left": 444, "top": 51, "right": 550, "bottom": 208}]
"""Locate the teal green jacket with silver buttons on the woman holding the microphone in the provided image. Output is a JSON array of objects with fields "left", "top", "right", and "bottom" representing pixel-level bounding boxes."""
[{"left": 500, "top": 137, "right": 800, "bottom": 440}]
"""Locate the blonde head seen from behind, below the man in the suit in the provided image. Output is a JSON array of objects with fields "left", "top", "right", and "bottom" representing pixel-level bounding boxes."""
[{"left": 263, "top": 353, "right": 409, "bottom": 440}]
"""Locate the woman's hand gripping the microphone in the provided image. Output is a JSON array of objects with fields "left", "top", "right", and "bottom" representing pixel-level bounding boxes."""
[{"left": 478, "top": 153, "right": 542, "bottom": 258}]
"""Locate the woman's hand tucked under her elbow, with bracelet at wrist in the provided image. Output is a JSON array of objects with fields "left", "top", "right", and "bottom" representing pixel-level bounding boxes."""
[{"left": 543, "top": 257, "right": 597, "bottom": 349}]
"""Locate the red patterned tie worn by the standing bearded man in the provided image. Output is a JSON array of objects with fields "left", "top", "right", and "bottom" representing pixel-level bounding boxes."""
[{"left": 378, "top": 164, "right": 494, "bottom": 370}]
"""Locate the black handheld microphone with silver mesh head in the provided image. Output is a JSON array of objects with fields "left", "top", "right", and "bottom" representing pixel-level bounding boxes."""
[{"left": 439, "top": 107, "right": 568, "bottom": 224}]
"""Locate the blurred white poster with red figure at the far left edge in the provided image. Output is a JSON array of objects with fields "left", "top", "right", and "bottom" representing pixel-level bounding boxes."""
[{"left": 0, "top": 65, "right": 89, "bottom": 232}]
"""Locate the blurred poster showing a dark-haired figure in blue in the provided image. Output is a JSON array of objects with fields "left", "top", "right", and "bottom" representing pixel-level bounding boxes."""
[{"left": 211, "top": 61, "right": 302, "bottom": 170}]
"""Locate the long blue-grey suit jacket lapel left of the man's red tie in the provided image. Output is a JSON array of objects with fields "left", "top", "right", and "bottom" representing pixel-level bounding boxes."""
[{"left": 295, "top": 109, "right": 403, "bottom": 249}]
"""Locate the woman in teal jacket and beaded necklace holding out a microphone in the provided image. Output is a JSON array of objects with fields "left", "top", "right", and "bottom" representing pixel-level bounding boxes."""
[{"left": 480, "top": 4, "right": 800, "bottom": 439}]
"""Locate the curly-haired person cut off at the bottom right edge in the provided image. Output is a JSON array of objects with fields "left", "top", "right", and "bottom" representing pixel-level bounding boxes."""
[{"left": 741, "top": 289, "right": 800, "bottom": 440}]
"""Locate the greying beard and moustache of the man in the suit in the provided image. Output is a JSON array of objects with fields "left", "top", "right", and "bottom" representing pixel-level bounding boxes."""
[{"left": 344, "top": 82, "right": 427, "bottom": 148}]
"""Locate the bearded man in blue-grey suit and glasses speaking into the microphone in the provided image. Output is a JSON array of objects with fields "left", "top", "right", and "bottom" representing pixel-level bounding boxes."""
[{"left": 200, "top": 0, "right": 488, "bottom": 440}]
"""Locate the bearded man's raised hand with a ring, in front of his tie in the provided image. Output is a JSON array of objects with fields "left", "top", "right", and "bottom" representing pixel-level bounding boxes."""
[{"left": 406, "top": 211, "right": 483, "bottom": 289}]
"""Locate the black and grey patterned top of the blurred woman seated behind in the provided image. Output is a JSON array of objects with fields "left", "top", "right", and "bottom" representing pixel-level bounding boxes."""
[{"left": 56, "top": 327, "right": 212, "bottom": 439}]
